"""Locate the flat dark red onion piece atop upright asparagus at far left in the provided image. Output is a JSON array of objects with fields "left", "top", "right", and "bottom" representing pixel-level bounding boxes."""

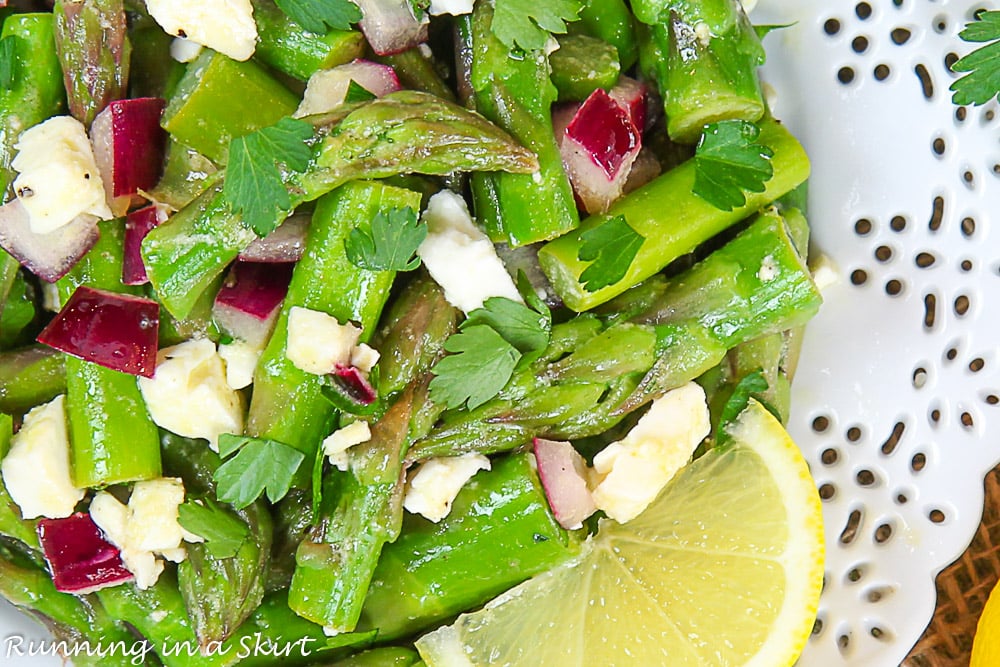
[{"left": 37, "top": 286, "right": 160, "bottom": 377}]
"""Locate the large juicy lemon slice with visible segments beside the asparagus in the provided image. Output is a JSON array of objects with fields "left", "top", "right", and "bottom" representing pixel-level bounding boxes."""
[{"left": 416, "top": 403, "right": 823, "bottom": 667}]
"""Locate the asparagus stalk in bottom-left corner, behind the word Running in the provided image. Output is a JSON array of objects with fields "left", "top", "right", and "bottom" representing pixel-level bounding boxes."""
[{"left": 0, "top": 554, "right": 139, "bottom": 667}]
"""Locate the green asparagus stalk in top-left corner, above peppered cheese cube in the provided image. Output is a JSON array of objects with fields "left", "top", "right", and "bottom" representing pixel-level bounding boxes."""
[{"left": 0, "top": 14, "right": 66, "bottom": 197}]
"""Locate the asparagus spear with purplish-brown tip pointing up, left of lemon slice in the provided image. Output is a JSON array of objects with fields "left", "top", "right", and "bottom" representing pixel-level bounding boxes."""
[{"left": 289, "top": 280, "right": 456, "bottom": 632}]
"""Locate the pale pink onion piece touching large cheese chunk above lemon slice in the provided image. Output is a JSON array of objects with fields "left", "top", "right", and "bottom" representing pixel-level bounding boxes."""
[{"left": 534, "top": 438, "right": 597, "bottom": 530}]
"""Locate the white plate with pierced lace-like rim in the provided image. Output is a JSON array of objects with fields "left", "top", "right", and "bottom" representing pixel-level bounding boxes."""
[{"left": 0, "top": 0, "right": 1000, "bottom": 667}]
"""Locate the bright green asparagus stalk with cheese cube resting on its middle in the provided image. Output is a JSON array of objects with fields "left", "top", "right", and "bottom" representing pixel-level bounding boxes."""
[{"left": 247, "top": 181, "right": 420, "bottom": 468}]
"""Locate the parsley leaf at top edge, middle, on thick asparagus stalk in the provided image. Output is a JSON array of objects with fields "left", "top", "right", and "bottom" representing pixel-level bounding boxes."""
[{"left": 492, "top": 0, "right": 583, "bottom": 51}]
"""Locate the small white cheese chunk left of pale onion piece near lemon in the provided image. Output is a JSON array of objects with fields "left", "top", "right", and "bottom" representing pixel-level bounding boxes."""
[{"left": 403, "top": 454, "right": 490, "bottom": 523}]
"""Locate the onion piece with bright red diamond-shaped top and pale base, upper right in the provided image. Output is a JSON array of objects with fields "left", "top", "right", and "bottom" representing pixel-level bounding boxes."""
[{"left": 553, "top": 89, "right": 642, "bottom": 214}]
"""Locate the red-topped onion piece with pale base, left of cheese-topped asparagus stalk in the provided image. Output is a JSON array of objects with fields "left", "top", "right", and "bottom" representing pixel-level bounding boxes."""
[{"left": 212, "top": 262, "right": 294, "bottom": 346}]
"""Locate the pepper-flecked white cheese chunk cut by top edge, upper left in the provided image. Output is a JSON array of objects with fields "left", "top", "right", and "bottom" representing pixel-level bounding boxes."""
[{"left": 146, "top": 0, "right": 257, "bottom": 60}]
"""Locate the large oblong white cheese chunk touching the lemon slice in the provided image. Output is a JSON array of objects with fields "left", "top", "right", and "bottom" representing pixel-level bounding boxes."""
[{"left": 593, "top": 382, "right": 711, "bottom": 523}]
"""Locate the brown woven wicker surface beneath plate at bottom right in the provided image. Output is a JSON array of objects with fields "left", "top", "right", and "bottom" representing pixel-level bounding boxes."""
[{"left": 903, "top": 466, "right": 1000, "bottom": 667}]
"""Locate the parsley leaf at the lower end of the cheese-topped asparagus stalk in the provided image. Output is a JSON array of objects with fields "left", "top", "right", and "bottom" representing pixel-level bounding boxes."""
[{"left": 214, "top": 436, "right": 305, "bottom": 509}]
